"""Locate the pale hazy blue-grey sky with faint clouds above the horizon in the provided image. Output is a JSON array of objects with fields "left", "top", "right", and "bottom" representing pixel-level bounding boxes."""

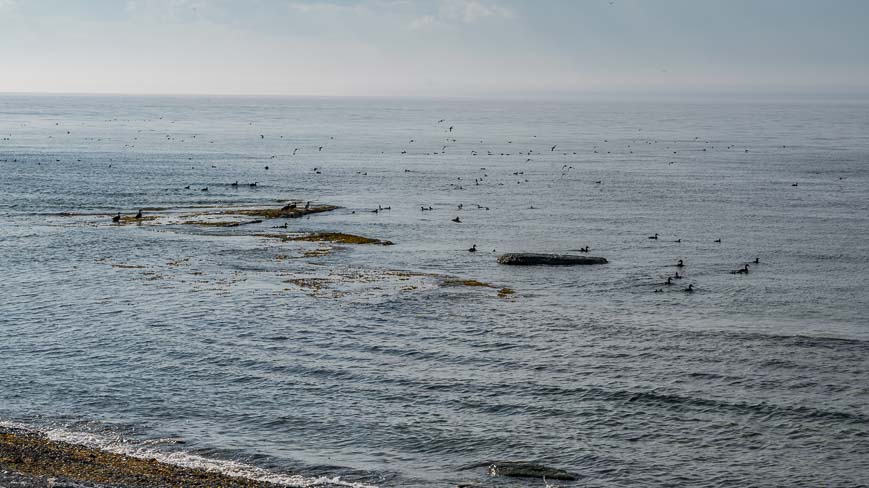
[{"left": 0, "top": 0, "right": 869, "bottom": 97}]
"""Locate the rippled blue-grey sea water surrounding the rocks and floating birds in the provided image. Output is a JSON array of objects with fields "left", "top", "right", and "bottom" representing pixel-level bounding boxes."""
[{"left": 0, "top": 96, "right": 869, "bottom": 487}]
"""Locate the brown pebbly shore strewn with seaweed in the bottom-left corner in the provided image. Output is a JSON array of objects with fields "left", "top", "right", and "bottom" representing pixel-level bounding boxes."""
[{"left": 0, "top": 427, "right": 278, "bottom": 488}]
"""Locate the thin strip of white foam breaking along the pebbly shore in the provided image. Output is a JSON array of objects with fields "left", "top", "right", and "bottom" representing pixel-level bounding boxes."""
[{"left": 0, "top": 420, "right": 377, "bottom": 488}]
